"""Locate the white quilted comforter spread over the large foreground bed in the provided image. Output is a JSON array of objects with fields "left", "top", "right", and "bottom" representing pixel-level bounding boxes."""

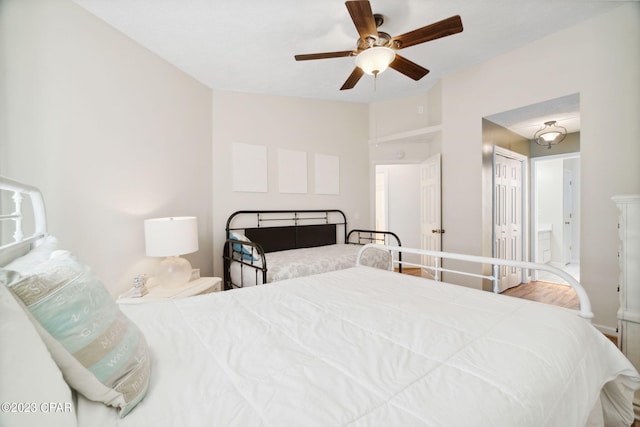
[{"left": 78, "top": 267, "right": 640, "bottom": 427}]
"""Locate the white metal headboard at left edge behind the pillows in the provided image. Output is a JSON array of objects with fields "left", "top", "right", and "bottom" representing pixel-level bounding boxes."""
[{"left": 0, "top": 176, "right": 47, "bottom": 265}]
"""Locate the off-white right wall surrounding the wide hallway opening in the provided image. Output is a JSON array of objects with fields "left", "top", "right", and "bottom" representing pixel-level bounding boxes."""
[{"left": 442, "top": 2, "right": 640, "bottom": 328}]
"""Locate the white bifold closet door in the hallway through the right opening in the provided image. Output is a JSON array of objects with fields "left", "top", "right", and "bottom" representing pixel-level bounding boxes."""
[{"left": 493, "top": 153, "right": 522, "bottom": 292}]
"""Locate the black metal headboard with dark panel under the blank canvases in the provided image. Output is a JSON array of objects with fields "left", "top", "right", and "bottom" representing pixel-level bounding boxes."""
[{"left": 226, "top": 209, "right": 347, "bottom": 252}]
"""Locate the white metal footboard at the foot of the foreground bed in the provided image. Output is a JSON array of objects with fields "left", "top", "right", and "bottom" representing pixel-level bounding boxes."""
[{"left": 356, "top": 244, "right": 593, "bottom": 319}]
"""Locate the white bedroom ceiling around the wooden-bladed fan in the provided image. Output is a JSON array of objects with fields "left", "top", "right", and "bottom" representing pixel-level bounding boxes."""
[{"left": 74, "top": 0, "right": 624, "bottom": 103}]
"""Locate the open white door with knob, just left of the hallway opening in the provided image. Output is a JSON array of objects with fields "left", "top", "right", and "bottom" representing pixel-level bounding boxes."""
[{"left": 420, "top": 154, "right": 444, "bottom": 280}]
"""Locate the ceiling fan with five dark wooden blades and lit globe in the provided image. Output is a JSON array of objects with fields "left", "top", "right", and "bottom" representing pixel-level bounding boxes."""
[{"left": 295, "top": 0, "right": 462, "bottom": 90}]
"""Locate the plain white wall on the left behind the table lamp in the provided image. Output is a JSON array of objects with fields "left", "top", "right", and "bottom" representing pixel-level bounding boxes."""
[{"left": 0, "top": 0, "right": 212, "bottom": 294}]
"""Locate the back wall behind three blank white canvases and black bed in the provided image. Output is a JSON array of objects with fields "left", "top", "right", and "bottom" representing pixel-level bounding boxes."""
[{"left": 212, "top": 91, "right": 373, "bottom": 276}]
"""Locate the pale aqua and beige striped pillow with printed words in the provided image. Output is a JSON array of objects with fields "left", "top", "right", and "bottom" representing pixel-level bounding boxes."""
[{"left": 10, "top": 251, "right": 150, "bottom": 417}]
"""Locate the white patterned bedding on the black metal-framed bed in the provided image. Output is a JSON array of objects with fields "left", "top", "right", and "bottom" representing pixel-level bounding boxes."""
[{"left": 231, "top": 244, "right": 390, "bottom": 286}]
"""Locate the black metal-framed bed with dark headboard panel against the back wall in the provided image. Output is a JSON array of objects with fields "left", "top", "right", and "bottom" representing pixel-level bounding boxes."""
[{"left": 223, "top": 209, "right": 400, "bottom": 289}]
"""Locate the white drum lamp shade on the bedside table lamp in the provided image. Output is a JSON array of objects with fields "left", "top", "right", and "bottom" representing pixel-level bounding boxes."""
[{"left": 144, "top": 216, "right": 198, "bottom": 257}]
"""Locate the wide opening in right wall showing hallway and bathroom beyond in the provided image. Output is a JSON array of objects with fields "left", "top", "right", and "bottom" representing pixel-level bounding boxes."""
[{"left": 483, "top": 94, "right": 580, "bottom": 292}]
